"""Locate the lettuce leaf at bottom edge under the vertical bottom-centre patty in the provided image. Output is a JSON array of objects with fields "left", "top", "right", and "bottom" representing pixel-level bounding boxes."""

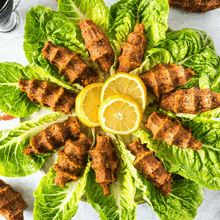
[{"left": 86, "top": 166, "right": 137, "bottom": 220}]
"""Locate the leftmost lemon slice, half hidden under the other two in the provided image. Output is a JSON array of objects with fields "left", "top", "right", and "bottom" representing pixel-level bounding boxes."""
[{"left": 76, "top": 83, "right": 103, "bottom": 127}]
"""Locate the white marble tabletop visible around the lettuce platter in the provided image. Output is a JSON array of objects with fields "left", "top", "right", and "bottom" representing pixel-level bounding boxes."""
[{"left": 0, "top": 0, "right": 220, "bottom": 220}]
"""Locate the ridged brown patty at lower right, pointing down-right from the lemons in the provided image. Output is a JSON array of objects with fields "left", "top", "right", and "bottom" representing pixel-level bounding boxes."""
[{"left": 127, "top": 138, "right": 173, "bottom": 196}]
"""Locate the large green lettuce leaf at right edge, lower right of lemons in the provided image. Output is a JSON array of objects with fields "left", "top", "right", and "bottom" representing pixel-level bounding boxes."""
[{"left": 135, "top": 122, "right": 220, "bottom": 190}]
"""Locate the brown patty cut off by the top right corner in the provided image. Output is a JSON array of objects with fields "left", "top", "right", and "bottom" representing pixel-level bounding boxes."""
[{"left": 169, "top": 0, "right": 220, "bottom": 13}]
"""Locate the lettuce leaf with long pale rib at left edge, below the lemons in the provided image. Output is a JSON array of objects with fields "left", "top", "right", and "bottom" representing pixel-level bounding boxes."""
[{"left": 0, "top": 113, "right": 68, "bottom": 177}]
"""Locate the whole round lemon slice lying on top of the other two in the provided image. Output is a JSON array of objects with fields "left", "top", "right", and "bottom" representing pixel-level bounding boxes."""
[{"left": 99, "top": 95, "right": 142, "bottom": 135}]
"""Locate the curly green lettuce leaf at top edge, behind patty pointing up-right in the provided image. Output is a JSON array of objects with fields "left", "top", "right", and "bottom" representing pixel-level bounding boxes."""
[{"left": 108, "top": 0, "right": 169, "bottom": 74}]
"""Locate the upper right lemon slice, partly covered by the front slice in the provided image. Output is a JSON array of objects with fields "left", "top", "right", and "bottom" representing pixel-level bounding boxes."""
[{"left": 101, "top": 73, "right": 147, "bottom": 111}]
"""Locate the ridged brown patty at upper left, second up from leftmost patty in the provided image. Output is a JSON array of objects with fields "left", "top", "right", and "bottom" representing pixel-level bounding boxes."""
[{"left": 42, "top": 41, "right": 97, "bottom": 86}]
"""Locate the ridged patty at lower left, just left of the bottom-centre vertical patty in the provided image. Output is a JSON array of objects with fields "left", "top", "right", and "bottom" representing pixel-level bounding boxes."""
[{"left": 53, "top": 133, "right": 92, "bottom": 187}]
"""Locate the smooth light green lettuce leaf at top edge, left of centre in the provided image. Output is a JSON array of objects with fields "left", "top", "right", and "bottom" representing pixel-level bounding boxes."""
[{"left": 58, "top": 0, "right": 109, "bottom": 33}]
